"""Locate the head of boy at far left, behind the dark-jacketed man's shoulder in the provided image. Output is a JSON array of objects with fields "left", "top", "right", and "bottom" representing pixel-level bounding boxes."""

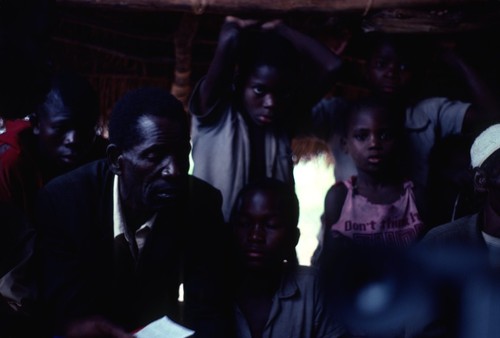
[{"left": 31, "top": 72, "right": 99, "bottom": 172}]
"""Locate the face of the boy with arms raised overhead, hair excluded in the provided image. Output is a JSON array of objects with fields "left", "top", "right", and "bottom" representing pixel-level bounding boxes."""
[{"left": 243, "top": 65, "right": 291, "bottom": 126}]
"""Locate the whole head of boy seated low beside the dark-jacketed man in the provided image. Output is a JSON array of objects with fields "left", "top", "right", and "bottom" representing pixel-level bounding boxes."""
[{"left": 231, "top": 178, "right": 300, "bottom": 270}]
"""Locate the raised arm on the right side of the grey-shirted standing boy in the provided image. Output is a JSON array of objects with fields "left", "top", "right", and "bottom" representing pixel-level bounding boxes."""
[{"left": 270, "top": 21, "right": 342, "bottom": 106}]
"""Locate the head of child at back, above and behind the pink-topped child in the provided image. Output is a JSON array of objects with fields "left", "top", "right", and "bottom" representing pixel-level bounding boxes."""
[{"left": 366, "top": 33, "right": 418, "bottom": 97}]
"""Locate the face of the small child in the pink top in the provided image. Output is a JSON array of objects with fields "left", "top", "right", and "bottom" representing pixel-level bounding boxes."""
[{"left": 344, "top": 108, "right": 396, "bottom": 172}]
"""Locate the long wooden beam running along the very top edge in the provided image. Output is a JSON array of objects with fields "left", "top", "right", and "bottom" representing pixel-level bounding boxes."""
[{"left": 56, "top": 0, "right": 491, "bottom": 14}]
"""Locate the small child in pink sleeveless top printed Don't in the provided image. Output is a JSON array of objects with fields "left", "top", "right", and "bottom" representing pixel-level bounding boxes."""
[{"left": 323, "top": 99, "right": 423, "bottom": 254}]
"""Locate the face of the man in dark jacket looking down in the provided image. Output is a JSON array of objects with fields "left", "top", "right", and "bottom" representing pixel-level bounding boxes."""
[{"left": 118, "top": 115, "right": 191, "bottom": 211}]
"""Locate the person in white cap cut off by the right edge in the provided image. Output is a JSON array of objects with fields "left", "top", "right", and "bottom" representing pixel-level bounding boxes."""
[{"left": 423, "top": 124, "right": 500, "bottom": 267}]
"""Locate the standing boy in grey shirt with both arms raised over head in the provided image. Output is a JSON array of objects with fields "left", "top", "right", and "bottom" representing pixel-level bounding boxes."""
[{"left": 189, "top": 17, "right": 340, "bottom": 220}]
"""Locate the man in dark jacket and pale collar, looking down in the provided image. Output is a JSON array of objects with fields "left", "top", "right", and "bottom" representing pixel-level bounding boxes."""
[{"left": 37, "top": 88, "right": 229, "bottom": 337}]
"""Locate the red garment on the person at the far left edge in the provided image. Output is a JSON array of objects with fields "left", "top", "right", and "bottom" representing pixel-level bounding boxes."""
[{"left": 0, "top": 120, "right": 43, "bottom": 217}]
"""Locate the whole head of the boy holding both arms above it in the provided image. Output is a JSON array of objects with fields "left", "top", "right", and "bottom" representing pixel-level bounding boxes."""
[{"left": 235, "top": 32, "right": 300, "bottom": 126}]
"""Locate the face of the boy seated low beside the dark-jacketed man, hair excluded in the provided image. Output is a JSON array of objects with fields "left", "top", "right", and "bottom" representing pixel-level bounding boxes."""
[{"left": 233, "top": 190, "right": 298, "bottom": 270}]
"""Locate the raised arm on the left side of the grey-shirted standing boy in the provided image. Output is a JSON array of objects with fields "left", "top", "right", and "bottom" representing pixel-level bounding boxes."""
[{"left": 195, "top": 16, "right": 256, "bottom": 116}]
